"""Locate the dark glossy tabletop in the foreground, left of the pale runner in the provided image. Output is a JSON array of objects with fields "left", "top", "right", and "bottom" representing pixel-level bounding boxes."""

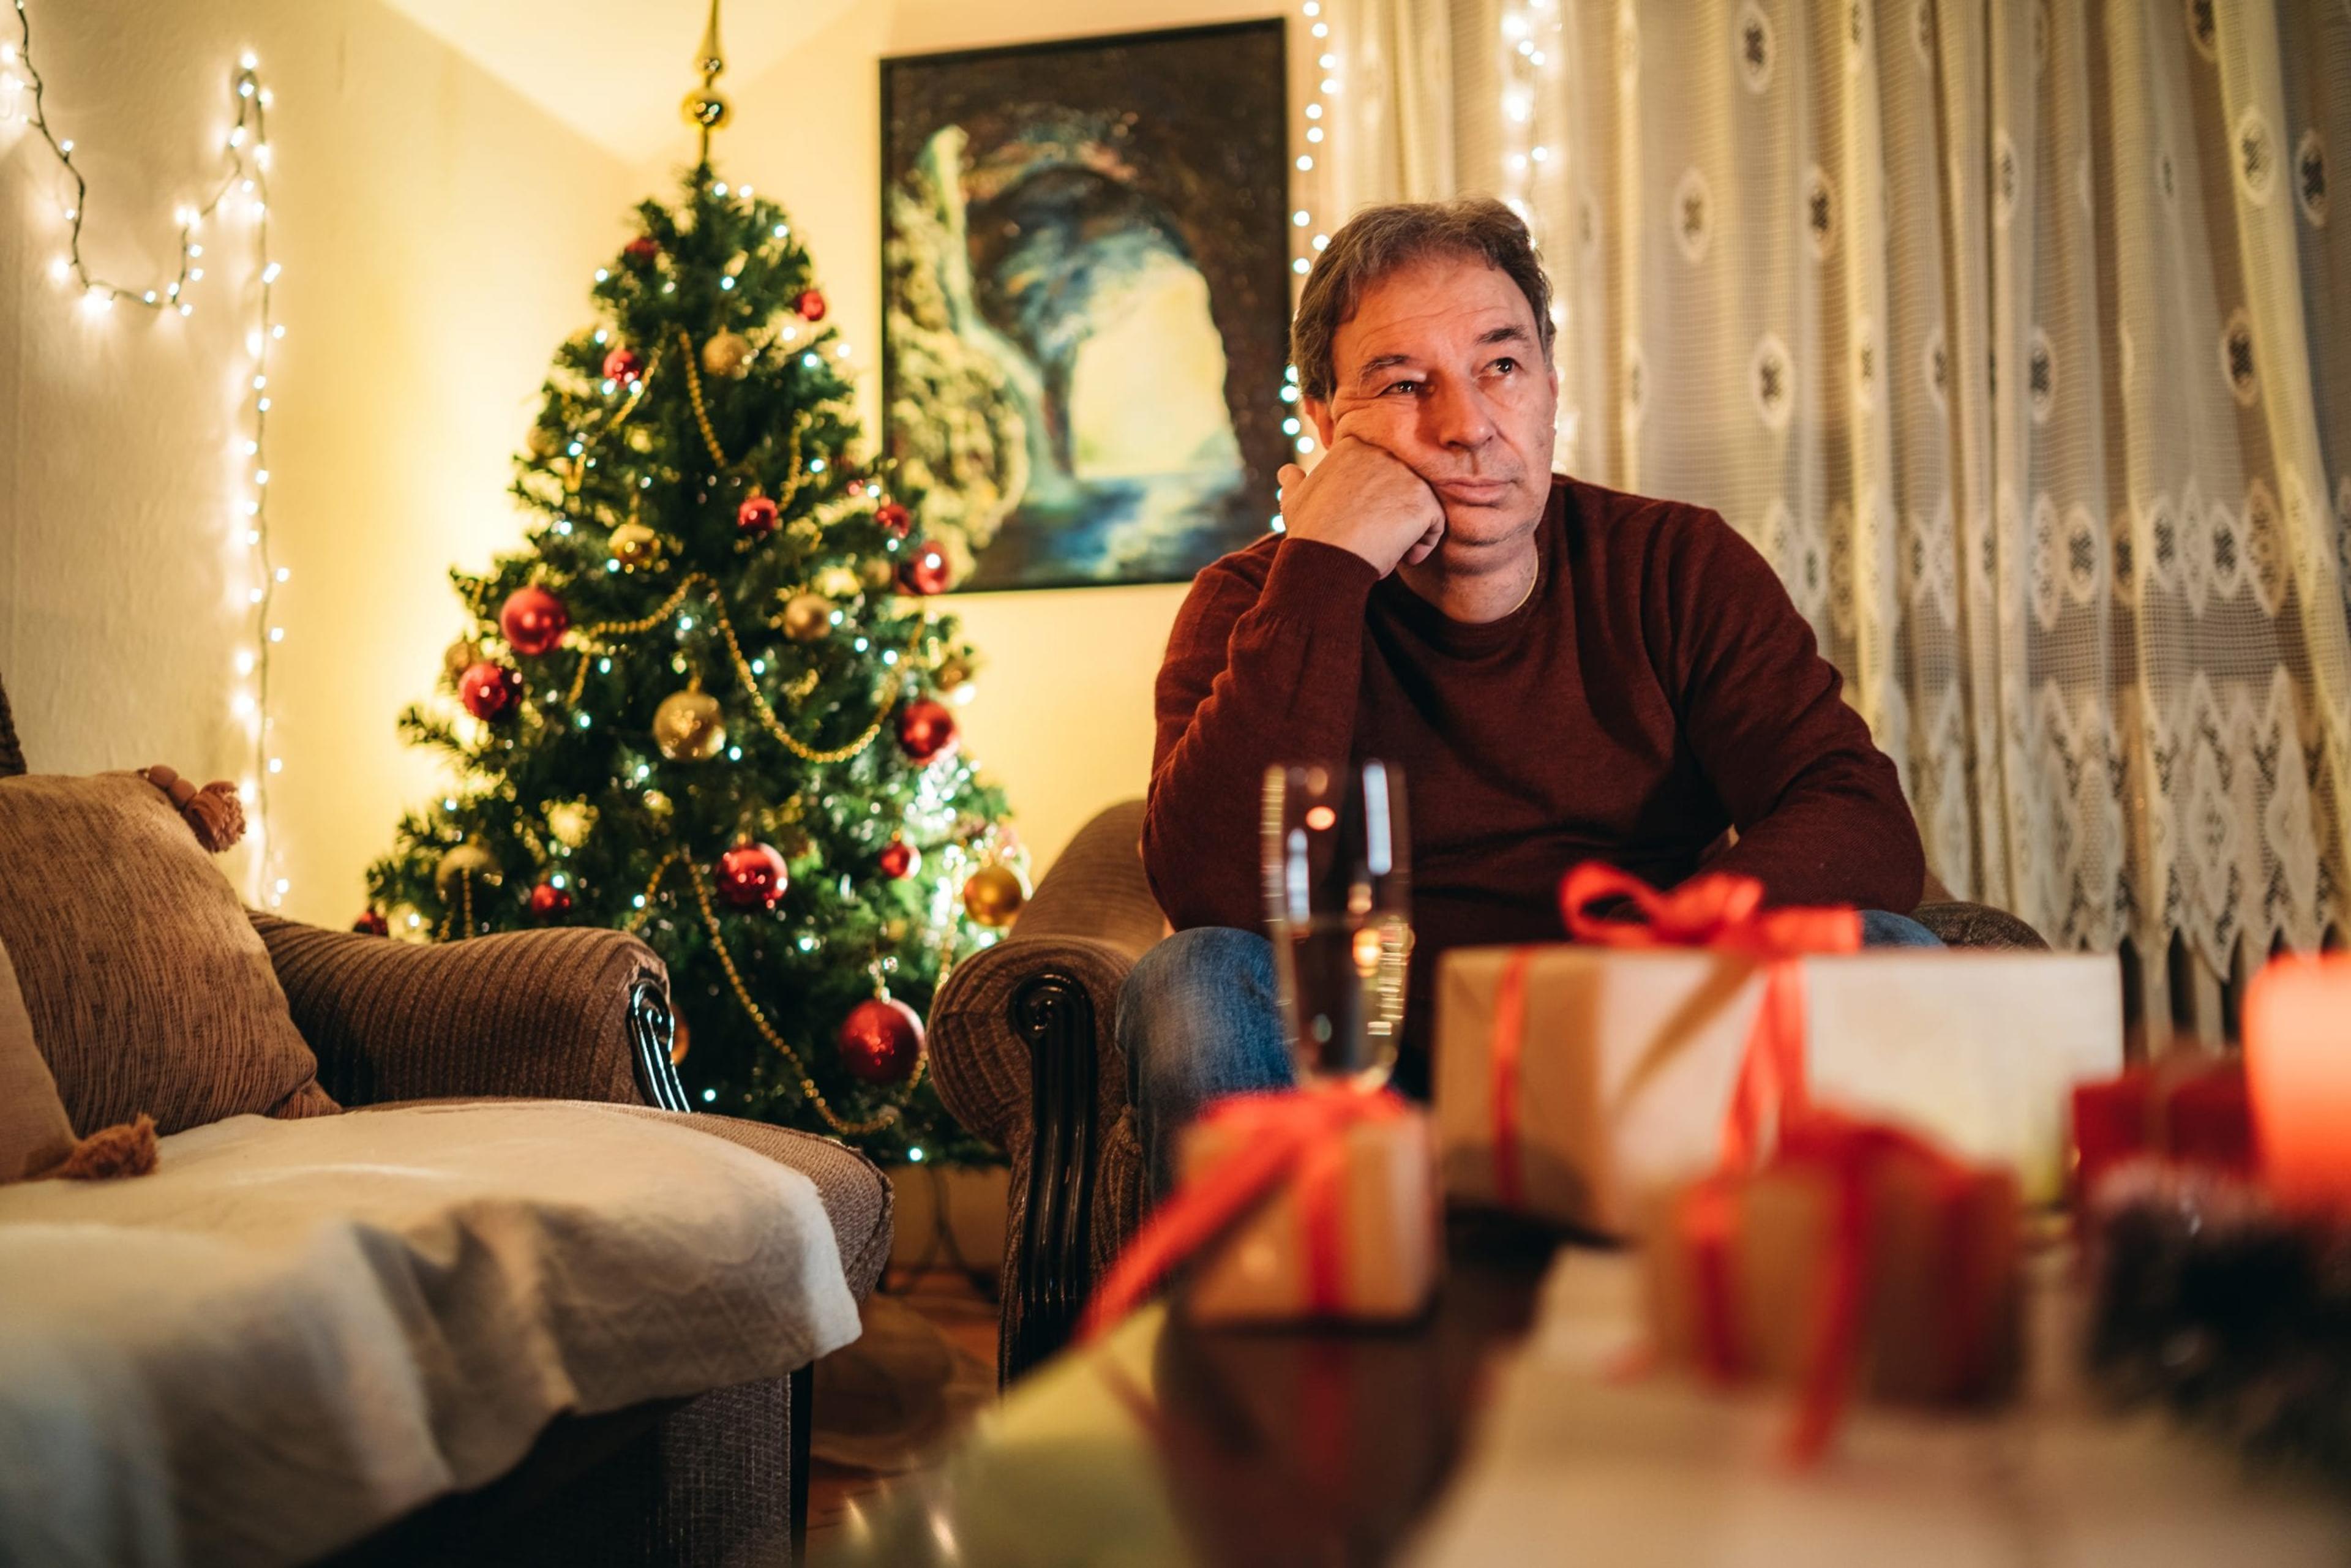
[{"left": 818, "top": 1220, "right": 1559, "bottom": 1568}]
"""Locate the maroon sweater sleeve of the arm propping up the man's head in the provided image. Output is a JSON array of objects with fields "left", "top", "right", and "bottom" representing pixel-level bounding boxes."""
[{"left": 1142, "top": 538, "right": 1378, "bottom": 931}]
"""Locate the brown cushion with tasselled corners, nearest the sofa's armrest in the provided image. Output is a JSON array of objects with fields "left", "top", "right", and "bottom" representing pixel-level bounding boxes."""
[{"left": 0, "top": 773, "right": 336, "bottom": 1136}]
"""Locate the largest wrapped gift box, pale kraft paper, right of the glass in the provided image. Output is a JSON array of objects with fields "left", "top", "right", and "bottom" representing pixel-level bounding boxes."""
[{"left": 1434, "top": 943, "right": 2123, "bottom": 1234}]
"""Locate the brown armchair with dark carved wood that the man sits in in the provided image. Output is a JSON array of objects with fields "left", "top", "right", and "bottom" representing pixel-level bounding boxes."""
[{"left": 931, "top": 799, "right": 2048, "bottom": 1382}]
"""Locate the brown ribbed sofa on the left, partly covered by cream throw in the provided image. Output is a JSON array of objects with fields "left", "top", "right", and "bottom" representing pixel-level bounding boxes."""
[{"left": 0, "top": 691, "right": 891, "bottom": 1563}]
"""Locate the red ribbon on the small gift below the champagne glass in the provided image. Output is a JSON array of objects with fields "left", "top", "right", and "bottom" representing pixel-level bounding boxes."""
[{"left": 1079, "top": 1086, "right": 1403, "bottom": 1340}]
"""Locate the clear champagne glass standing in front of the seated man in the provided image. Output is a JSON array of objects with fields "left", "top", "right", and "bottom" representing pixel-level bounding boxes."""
[{"left": 1262, "top": 762, "right": 1413, "bottom": 1089}]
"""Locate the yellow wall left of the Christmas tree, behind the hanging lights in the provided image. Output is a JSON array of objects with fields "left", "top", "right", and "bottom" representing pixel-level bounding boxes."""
[{"left": 0, "top": 0, "right": 635, "bottom": 924}]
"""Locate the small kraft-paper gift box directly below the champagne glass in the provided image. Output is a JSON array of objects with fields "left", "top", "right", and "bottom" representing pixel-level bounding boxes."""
[{"left": 1178, "top": 1112, "right": 1444, "bottom": 1324}]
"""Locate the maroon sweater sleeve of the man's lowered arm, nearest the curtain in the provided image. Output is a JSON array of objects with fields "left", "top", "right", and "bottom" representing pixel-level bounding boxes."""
[{"left": 1648, "top": 510, "right": 1925, "bottom": 915}]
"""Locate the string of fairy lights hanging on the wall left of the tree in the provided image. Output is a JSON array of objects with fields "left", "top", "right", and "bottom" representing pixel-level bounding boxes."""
[{"left": 0, "top": 0, "right": 291, "bottom": 907}]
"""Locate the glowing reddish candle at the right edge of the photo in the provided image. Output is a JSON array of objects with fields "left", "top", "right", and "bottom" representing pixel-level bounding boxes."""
[{"left": 2245, "top": 952, "right": 2351, "bottom": 1213}]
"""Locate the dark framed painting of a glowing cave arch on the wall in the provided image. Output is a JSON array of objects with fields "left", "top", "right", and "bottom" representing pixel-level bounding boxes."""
[{"left": 882, "top": 19, "right": 1291, "bottom": 590}]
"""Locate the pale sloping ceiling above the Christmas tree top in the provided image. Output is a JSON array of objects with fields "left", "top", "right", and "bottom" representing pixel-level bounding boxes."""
[{"left": 367, "top": 0, "right": 853, "bottom": 162}]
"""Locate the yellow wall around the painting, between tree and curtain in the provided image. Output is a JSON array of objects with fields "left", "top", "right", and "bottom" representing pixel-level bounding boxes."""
[{"left": 639, "top": 0, "right": 1298, "bottom": 872}]
